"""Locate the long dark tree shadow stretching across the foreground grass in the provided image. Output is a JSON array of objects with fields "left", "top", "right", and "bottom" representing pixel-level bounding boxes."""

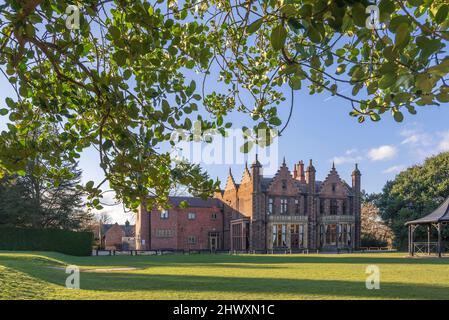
[{"left": 3, "top": 258, "right": 449, "bottom": 299}]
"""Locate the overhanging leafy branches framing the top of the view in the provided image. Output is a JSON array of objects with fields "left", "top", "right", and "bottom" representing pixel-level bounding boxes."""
[{"left": 0, "top": 0, "right": 449, "bottom": 207}]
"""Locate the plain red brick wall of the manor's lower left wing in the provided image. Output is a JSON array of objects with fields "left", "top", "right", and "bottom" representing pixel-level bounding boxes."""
[{"left": 151, "top": 207, "right": 223, "bottom": 250}]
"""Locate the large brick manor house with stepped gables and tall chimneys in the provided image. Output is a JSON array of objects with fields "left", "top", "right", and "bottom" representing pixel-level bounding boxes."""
[{"left": 136, "top": 157, "right": 361, "bottom": 252}]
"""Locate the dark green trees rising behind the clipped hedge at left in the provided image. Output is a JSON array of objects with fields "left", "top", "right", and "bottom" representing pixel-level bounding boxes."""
[{"left": 0, "top": 160, "right": 93, "bottom": 230}]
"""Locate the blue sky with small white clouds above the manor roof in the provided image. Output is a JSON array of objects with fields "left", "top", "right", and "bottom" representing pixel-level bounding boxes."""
[{"left": 0, "top": 59, "right": 449, "bottom": 222}]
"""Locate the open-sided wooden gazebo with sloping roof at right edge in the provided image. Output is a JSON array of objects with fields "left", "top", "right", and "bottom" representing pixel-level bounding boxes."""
[{"left": 405, "top": 197, "right": 449, "bottom": 258}]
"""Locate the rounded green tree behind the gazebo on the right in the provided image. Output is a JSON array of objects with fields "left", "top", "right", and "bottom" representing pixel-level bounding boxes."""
[{"left": 374, "top": 153, "right": 449, "bottom": 248}]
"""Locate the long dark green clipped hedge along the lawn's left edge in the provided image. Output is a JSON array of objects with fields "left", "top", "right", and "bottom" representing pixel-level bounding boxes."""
[{"left": 0, "top": 227, "right": 94, "bottom": 256}]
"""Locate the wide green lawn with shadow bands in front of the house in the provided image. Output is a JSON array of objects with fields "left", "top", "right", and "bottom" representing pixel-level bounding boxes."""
[{"left": 0, "top": 252, "right": 449, "bottom": 299}]
